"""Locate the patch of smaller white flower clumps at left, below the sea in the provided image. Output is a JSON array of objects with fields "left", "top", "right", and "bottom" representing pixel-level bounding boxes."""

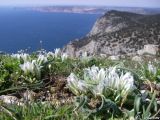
[{"left": 11, "top": 48, "right": 68, "bottom": 74}]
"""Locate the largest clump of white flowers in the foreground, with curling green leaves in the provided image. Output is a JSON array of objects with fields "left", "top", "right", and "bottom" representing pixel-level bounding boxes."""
[{"left": 67, "top": 66, "right": 135, "bottom": 96}]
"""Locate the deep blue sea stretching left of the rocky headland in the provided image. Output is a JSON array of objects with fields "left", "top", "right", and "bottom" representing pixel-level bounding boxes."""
[{"left": 0, "top": 8, "right": 100, "bottom": 53}]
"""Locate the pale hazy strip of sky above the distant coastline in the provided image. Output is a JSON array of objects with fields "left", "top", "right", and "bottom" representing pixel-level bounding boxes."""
[{"left": 0, "top": 0, "right": 160, "bottom": 8}]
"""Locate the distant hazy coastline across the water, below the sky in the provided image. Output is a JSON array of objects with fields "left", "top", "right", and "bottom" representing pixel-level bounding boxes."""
[{"left": 28, "top": 6, "right": 160, "bottom": 14}]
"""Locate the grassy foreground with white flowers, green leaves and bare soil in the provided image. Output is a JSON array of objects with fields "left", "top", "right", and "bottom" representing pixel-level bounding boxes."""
[{"left": 0, "top": 49, "right": 160, "bottom": 120}]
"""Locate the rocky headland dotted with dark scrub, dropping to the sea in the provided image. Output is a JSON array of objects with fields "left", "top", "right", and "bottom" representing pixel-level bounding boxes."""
[{"left": 63, "top": 11, "right": 160, "bottom": 56}]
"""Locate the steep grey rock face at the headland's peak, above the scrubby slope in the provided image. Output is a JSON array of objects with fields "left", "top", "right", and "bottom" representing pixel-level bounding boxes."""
[{"left": 89, "top": 11, "right": 141, "bottom": 36}]
